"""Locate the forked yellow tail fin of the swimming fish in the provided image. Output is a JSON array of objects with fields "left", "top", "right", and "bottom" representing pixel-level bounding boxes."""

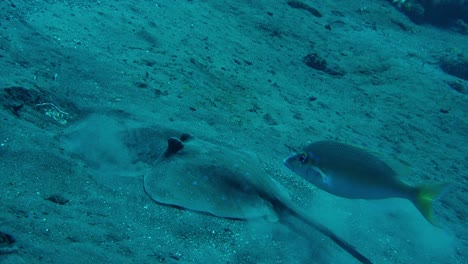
[{"left": 411, "top": 183, "right": 449, "bottom": 225}]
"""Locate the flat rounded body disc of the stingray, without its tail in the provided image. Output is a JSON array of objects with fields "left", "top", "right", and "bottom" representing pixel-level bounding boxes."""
[{"left": 144, "top": 138, "right": 277, "bottom": 219}]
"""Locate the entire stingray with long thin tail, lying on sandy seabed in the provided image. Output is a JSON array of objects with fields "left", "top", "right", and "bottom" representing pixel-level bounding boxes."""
[{"left": 144, "top": 134, "right": 371, "bottom": 263}]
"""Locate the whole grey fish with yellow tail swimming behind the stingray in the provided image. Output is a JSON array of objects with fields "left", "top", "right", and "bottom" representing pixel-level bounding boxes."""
[{"left": 284, "top": 141, "right": 449, "bottom": 226}]
